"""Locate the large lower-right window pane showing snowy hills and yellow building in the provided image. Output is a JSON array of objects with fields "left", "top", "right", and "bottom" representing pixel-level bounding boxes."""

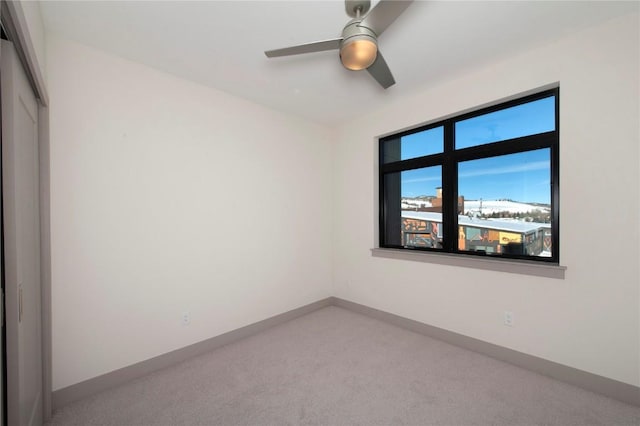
[{"left": 458, "top": 148, "right": 552, "bottom": 257}]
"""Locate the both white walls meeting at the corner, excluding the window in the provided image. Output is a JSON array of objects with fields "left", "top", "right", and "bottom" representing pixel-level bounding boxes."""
[{"left": 46, "top": 8, "right": 640, "bottom": 390}]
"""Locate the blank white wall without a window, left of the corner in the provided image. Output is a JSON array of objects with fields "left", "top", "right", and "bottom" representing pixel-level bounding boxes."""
[{"left": 47, "top": 36, "right": 332, "bottom": 390}]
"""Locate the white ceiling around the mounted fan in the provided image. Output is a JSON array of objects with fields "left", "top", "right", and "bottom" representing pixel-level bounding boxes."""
[{"left": 41, "top": 0, "right": 638, "bottom": 125}]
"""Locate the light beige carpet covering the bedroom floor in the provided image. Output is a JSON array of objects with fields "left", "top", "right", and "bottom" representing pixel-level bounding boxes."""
[{"left": 49, "top": 307, "right": 640, "bottom": 426}]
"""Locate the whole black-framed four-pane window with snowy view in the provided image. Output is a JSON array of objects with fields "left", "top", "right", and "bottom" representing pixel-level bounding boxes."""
[{"left": 379, "top": 89, "right": 559, "bottom": 263}]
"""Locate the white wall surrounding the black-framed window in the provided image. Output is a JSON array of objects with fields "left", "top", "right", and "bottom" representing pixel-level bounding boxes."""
[{"left": 334, "top": 14, "right": 640, "bottom": 385}]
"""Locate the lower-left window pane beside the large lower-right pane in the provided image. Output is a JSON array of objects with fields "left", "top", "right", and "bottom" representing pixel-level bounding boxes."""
[{"left": 384, "top": 166, "right": 443, "bottom": 248}]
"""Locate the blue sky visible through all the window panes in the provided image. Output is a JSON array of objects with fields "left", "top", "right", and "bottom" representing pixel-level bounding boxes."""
[{"left": 401, "top": 97, "right": 555, "bottom": 204}]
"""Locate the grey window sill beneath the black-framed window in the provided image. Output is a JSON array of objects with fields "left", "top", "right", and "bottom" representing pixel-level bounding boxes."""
[{"left": 371, "top": 248, "right": 567, "bottom": 280}]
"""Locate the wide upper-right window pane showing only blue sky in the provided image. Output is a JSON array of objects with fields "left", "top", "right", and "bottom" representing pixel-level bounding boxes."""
[{"left": 455, "top": 96, "right": 556, "bottom": 149}]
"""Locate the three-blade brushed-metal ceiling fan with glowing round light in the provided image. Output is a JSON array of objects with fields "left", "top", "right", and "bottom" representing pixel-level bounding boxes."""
[{"left": 264, "top": 0, "right": 413, "bottom": 89}]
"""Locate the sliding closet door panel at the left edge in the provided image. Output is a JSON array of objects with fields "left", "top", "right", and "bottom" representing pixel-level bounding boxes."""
[{"left": 1, "top": 40, "right": 43, "bottom": 426}]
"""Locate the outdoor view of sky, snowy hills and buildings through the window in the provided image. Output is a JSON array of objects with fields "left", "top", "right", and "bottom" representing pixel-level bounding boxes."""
[{"left": 400, "top": 96, "right": 555, "bottom": 257}]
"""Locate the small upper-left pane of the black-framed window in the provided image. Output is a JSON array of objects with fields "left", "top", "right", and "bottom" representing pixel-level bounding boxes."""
[{"left": 382, "top": 127, "right": 444, "bottom": 164}]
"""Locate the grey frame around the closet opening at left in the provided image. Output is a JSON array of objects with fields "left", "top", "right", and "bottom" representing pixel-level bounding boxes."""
[{"left": 0, "top": 0, "right": 53, "bottom": 423}]
